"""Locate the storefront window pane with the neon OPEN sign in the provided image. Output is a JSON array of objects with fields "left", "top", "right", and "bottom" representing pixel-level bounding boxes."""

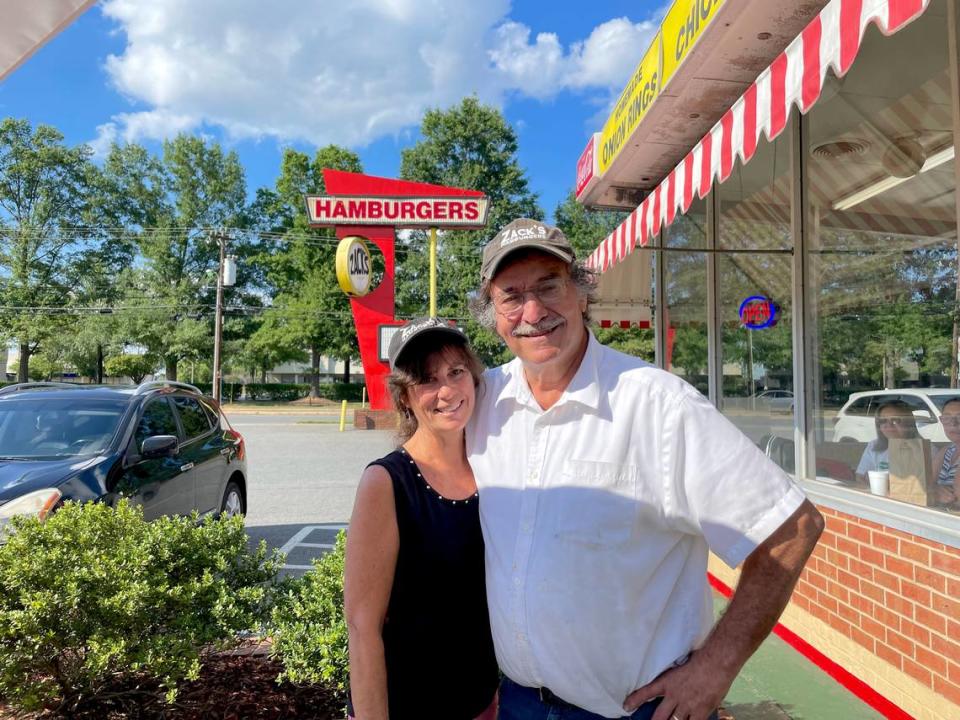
[{"left": 715, "top": 128, "right": 794, "bottom": 448}]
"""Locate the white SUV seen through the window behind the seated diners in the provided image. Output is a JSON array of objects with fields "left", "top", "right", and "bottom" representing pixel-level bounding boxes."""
[{"left": 833, "top": 388, "right": 960, "bottom": 442}]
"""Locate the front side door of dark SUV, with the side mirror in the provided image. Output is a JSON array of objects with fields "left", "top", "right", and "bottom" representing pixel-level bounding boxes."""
[{"left": 116, "top": 397, "right": 193, "bottom": 520}]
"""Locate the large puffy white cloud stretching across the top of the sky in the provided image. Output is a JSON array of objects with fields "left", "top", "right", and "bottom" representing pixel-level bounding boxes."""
[{"left": 94, "top": 0, "right": 653, "bottom": 149}]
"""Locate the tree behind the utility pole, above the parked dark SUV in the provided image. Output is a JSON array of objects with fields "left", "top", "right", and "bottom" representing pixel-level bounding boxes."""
[{"left": 104, "top": 135, "right": 249, "bottom": 380}]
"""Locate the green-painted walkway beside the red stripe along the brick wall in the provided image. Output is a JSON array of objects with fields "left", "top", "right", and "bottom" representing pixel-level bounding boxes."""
[{"left": 713, "top": 593, "right": 883, "bottom": 720}]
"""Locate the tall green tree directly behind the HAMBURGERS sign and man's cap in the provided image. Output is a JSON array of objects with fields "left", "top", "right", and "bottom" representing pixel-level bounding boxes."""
[{"left": 397, "top": 97, "right": 543, "bottom": 363}]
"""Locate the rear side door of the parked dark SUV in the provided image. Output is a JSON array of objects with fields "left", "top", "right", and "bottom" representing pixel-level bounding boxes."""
[{"left": 172, "top": 395, "right": 227, "bottom": 513}]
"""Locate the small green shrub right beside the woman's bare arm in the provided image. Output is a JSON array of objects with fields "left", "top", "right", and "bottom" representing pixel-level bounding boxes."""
[{"left": 272, "top": 532, "right": 350, "bottom": 702}]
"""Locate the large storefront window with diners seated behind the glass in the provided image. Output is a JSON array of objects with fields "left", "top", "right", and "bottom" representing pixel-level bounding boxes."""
[{"left": 806, "top": 0, "right": 960, "bottom": 512}]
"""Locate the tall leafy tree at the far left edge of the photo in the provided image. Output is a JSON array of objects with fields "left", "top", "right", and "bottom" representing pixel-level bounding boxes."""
[{"left": 0, "top": 118, "right": 92, "bottom": 382}]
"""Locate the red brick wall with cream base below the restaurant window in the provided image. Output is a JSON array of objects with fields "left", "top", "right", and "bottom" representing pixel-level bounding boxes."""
[{"left": 710, "top": 507, "right": 960, "bottom": 720}]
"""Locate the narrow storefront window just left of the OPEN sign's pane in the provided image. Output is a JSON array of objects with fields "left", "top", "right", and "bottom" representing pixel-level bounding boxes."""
[{"left": 662, "top": 195, "right": 709, "bottom": 395}]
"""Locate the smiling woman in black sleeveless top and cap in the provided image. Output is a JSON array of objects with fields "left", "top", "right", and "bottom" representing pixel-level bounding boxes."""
[{"left": 344, "top": 318, "right": 499, "bottom": 720}]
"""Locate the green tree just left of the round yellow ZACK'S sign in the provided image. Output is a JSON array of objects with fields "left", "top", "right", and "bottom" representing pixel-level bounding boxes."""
[{"left": 245, "top": 145, "right": 363, "bottom": 397}]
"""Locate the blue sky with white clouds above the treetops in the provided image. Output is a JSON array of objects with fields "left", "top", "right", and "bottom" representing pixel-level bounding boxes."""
[{"left": 0, "top": 0, "right": 668, "bottom": 218}]
